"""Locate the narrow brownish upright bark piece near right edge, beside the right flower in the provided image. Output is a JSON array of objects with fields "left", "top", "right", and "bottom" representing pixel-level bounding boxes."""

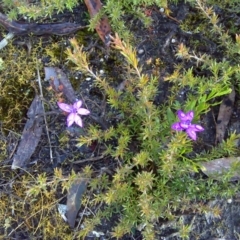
[{"left": 216, "top": 88, "right": 236, "bottom": 143}]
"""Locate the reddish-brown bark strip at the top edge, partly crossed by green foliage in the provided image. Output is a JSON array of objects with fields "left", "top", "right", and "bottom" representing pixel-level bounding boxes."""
[{"left": 84, "top": 0, "right": 111, "bottom": 46}]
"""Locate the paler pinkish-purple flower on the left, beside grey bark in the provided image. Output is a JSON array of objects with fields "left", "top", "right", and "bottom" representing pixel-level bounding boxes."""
[{"left": 57, "top": 100, "right": 90, "bottom": 127}]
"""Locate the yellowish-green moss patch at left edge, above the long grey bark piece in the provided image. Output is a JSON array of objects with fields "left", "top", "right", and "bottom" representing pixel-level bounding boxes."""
[{"left": 0, "top": 44, "right": 36, "bottom": 129}]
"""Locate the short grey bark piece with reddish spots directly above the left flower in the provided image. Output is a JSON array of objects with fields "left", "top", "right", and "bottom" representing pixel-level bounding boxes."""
[{"left": 44, "top": 67, "right": 77, "bottom": 103}]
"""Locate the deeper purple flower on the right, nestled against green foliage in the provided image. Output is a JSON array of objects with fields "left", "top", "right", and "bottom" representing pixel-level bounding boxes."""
[{"left": 172, "top": 110, "right": 204, "bottom": 140}]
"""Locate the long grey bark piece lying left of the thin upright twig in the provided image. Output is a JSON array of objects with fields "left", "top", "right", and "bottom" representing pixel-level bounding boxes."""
[{"left": 12, "top": 96, "right": 44, "bottom": 169}]
